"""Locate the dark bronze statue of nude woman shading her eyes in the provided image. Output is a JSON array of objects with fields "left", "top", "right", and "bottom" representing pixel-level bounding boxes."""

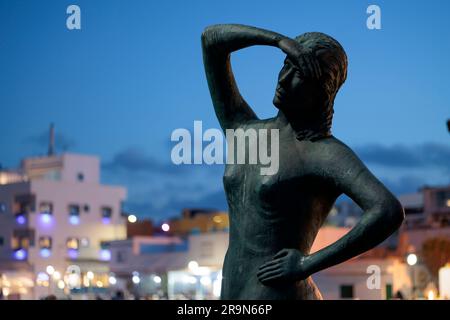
[{"left": 202, "top": 25, "right": 404, "bottom": 299}]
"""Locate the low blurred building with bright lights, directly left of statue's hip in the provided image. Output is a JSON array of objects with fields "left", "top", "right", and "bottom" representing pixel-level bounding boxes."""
[{"left": 110, "top": 231, "right": 228, "bottom": 299}]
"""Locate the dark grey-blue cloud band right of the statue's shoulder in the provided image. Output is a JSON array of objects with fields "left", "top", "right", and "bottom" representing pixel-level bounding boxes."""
[{"left": 355, "top": 143, "right": 450, "bottom": 172}]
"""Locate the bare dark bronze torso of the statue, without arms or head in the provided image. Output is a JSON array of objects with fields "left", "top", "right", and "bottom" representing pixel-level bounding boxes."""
[{"left": 222, "top": 119, "right": 337, "bottom": 299}]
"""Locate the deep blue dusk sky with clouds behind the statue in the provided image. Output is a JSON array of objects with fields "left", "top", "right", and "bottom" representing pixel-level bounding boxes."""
[{"left": 0, "top": 0, "right": 450, "bottom": 220}]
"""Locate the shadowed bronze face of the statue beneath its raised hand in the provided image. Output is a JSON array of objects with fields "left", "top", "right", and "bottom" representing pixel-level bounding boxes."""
[{"left": 273, "top": 58, "right": 317, "bottom": 112}]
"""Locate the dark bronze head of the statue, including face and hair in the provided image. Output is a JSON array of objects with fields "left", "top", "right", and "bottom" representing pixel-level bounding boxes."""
[{"left": 273, "top": 32, "right": 347, "bottom": 140}]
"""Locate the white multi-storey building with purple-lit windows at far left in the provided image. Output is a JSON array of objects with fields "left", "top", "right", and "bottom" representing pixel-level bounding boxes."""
[{"left": 0, "top": 153, "right": 126, "bottom": 298}]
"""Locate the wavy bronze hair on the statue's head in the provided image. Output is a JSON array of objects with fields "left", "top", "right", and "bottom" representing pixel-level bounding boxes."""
[{"left": 295, "top": 32, "right": 348, "bottom": 138}]
